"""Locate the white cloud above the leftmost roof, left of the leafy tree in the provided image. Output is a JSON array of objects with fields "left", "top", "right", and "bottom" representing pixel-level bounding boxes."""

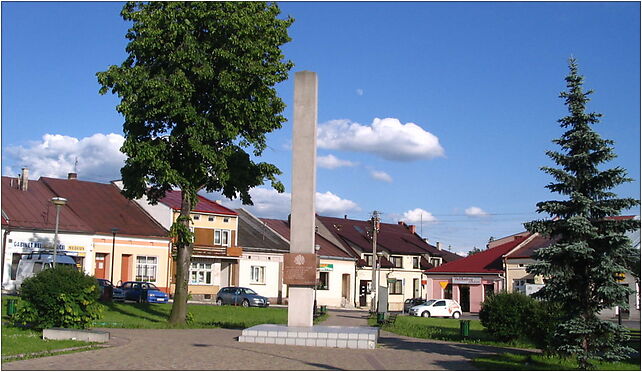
[{"left": 5, "top": 133, "right": 125, "bottom": 182}]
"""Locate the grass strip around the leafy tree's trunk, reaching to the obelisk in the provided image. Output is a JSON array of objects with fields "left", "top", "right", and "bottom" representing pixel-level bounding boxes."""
[{"left": 93, "top": 302, "right": 288, "bottom": 329}]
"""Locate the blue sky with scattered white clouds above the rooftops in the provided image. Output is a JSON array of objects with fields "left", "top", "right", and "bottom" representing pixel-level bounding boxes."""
[{"left": 2, "top": 2, "right": 640, "bottom": 252}]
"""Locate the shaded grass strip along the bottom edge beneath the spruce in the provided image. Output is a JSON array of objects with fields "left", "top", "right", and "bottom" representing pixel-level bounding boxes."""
[{"left": 473, "top": 353, "right": 640, "bottom": 371}]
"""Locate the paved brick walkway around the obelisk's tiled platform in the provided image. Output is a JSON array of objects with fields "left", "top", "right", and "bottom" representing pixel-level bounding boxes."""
[{"left": 2, "top": 309, "right": 528, "bottom": 370}]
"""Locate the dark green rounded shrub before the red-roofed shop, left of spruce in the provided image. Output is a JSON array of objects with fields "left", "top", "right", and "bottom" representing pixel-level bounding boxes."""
[{"left": 479, "top": 292, "right": 535, "bottom": 342}]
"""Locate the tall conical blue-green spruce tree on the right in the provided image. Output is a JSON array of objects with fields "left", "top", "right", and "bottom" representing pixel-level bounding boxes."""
[{"left": 525, "top": 58, "right": 640, "bottom": 368}]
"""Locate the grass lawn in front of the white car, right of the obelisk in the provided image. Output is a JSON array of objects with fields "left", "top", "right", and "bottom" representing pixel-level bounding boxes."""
[{"left": 368, "top": 315, "right": 535, "bottom": 349}]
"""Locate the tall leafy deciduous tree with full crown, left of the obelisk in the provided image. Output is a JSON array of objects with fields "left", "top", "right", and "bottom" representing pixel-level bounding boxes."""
[{"left": 96, "top": 2, "right": 293, "bottom": 324}]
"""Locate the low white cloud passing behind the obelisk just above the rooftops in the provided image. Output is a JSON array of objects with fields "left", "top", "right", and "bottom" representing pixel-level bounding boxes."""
[{"left": 204, "top": 187, "right": 359, "bottom": 219}]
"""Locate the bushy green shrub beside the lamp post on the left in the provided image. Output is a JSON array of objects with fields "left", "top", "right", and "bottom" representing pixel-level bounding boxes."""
[{"left": 13, "top": 265, "right": 103, "bottom": 329}]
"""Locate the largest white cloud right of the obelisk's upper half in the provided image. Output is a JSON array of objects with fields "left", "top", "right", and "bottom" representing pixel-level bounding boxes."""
[{"left": 317, "top": 118, "right": 444, "bottom": 161}]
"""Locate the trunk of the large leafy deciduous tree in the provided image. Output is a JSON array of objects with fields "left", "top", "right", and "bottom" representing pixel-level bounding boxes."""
[{"left": 169, "top": 191, "right": 194, "bottom": 325}]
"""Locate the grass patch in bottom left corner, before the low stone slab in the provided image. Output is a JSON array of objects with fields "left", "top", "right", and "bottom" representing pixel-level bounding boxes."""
[{"left": 2, "top": 324, "right": 93, "bottom": 359}]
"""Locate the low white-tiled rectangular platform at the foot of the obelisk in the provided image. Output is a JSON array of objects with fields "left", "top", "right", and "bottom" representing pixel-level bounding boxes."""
[{"left": 239, "top": 324, "right": 379, "bottom": 349}]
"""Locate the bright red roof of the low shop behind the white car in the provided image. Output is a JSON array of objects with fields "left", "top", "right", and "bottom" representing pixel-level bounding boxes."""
[{"left": 425, "top": 236, "right": 527, "bottom": 274}]
